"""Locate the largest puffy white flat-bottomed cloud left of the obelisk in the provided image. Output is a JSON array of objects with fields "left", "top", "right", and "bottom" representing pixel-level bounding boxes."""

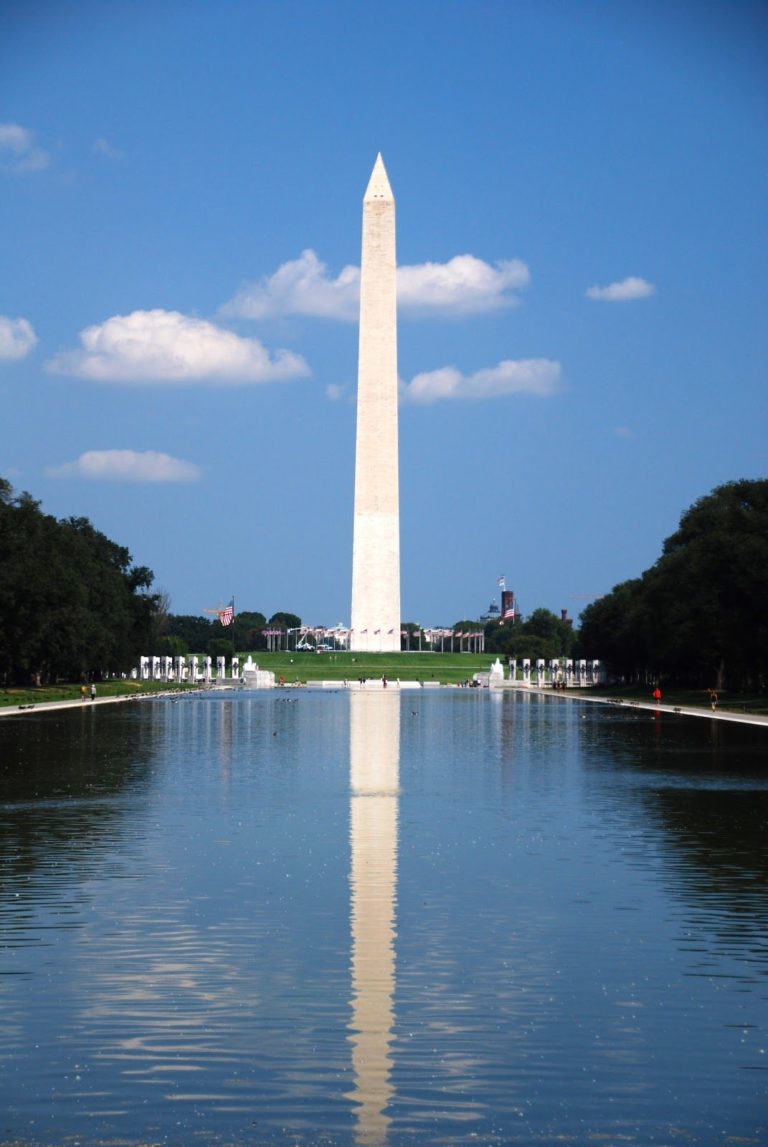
[{"left": 46, "top": 311, "right": 309, "bottom": 383}]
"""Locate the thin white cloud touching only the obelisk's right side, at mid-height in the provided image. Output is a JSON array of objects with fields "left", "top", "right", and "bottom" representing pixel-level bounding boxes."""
[{"left": 400, "top": 359, "right": 561, "bottom": 404}]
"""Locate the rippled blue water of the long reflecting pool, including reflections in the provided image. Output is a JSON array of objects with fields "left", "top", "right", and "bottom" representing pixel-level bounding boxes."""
[{"left": 0, "top": 690, "right": 768, "bottom": 1147}]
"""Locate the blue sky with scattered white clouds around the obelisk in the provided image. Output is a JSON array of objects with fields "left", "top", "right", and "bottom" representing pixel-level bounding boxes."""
[{"left": 0, "top": 0, "right": 768, "bottom": 625}]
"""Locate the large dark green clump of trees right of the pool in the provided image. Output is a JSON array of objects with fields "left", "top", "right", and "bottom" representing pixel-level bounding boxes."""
[{"left": 579, "top": 479, "right": 768, "bottom": 689}]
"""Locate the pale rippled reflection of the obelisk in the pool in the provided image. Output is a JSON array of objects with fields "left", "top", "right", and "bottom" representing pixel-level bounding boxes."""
[{"left": 350, "top": 690, "right": 400, "bottom": 1145}]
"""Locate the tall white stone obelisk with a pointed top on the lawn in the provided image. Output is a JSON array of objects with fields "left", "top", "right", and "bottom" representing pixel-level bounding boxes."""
[{"left": 350, "top": 155, "right": 400, "bottom": 651}]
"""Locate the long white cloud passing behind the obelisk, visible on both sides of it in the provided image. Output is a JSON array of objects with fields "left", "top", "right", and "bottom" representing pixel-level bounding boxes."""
[{"left": 221, "top": 250, "right": 531, "bottom": 322}]
